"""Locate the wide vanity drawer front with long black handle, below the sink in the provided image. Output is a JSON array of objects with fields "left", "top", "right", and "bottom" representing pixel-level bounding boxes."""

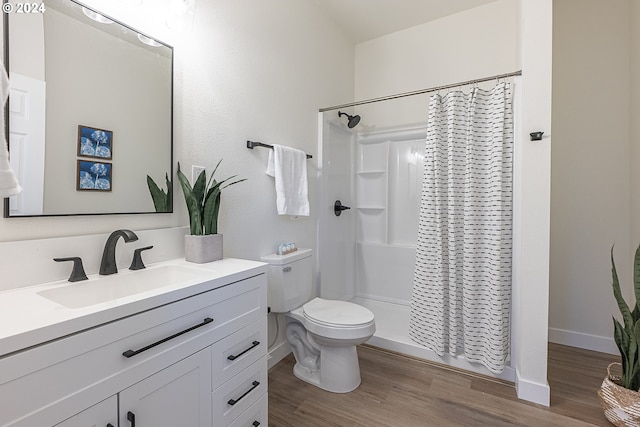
[{"left": 0, "top": 275, "right": 266, "bottom": 426}]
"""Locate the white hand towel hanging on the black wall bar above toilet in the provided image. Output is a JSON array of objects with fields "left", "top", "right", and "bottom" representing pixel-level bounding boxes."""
[{"left": 267, "top": 145, "right": 309, "bottom": 216}]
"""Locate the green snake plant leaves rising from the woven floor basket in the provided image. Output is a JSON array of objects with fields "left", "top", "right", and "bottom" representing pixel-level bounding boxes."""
[{"left": 611, "top": 246, "right": 640, "bottom": 391}]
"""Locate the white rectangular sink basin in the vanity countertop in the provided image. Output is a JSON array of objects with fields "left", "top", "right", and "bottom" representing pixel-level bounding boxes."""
[{"left": 38, "top": 265, "right": 211, "bottom": 308}]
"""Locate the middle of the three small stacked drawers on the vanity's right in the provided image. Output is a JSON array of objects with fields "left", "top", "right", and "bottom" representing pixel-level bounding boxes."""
[{"left": 212, "top": 356, "right": 267, "bottom": 426}]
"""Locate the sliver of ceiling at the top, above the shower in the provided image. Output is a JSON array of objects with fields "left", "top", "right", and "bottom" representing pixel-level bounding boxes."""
[{"left": 315, "top": 0, "right": 496, "bottom": 43}]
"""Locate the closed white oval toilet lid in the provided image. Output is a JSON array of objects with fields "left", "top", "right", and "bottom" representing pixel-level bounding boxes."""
[{"left": 302, "top": 298, "right": 373, "bottom": 327}]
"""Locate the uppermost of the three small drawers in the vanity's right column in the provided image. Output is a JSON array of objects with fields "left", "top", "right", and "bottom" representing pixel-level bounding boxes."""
[{"left": 211, "top": 318, "right": 267, "bottom": 390}]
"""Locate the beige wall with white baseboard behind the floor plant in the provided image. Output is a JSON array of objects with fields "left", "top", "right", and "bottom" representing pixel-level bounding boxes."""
[{"left": 549, "top": 0, "right": 640, "bottom": 353}]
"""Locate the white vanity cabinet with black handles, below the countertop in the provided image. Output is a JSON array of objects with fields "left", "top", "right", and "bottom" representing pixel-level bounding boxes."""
[{"left": 0, "top": 263, "right": 267, "bottom": 427}]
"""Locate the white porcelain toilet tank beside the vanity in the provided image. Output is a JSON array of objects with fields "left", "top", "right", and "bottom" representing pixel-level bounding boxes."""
[{"left": 261, "top": 249, "right": 315, "bottom": 313}]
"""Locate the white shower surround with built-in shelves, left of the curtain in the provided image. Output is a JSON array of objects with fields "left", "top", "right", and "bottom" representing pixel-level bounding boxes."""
[{"left": 318, "top": 112, "right": 516, "bottom": 381}]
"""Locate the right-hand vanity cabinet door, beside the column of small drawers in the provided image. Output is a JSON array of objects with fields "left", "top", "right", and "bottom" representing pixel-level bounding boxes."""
[{"left": 119, "top": 347, "right": 212, "bottom": 427}]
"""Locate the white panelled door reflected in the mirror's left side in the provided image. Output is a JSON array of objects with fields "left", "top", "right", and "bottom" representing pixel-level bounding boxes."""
[{"left": 9, "top": 73, "right": 46, "bottom": 215}]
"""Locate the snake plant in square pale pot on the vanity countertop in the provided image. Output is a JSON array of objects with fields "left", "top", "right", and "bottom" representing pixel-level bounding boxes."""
[{"left": 177, "top": 160, "right": 246, "bottom": 263}]
